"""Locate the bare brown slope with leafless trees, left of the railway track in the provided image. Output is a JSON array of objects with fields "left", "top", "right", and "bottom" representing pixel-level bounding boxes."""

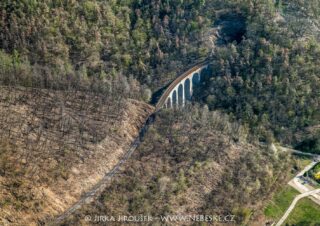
[{"left": 0, "top": 88, "right": 153, "bottom": 225}]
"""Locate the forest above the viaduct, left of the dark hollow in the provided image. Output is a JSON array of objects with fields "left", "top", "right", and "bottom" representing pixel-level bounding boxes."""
[{"left": 0, "top": 0, "right": 211, "bottom": 91}]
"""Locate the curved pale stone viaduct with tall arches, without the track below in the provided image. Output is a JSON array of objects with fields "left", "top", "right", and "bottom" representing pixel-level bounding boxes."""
[{"left": 156, "top": 61, "right": 208, "bottom": 110}]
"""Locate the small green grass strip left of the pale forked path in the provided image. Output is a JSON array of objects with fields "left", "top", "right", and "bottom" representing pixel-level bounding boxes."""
[{"left": 264, "top": 185, "right": 299, "bottom": 220}]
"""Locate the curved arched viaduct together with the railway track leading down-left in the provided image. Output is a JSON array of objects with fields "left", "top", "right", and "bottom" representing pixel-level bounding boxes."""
[{"left": 54, "top": 61, "right": 208, "bottom": 222}]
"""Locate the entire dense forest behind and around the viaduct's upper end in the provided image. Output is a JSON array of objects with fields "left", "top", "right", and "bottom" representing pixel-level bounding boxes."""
[{"left": 0, "top": 0, "right": 320, "bottom": 145}]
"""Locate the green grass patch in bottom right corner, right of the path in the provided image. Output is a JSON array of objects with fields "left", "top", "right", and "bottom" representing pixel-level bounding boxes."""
[{"left": 286, "top": 198, "right": 320, "bottom": 226}]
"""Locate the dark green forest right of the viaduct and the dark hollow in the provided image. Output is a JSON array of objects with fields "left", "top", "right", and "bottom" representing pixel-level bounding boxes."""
[{"left": 196, "top": 1, "right": 320, "bottom": 148}]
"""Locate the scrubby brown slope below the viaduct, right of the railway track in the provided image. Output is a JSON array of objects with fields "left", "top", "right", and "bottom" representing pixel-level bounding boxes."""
[{"left": 63, "top": 107, "right": 292, "bottom": 225}]
